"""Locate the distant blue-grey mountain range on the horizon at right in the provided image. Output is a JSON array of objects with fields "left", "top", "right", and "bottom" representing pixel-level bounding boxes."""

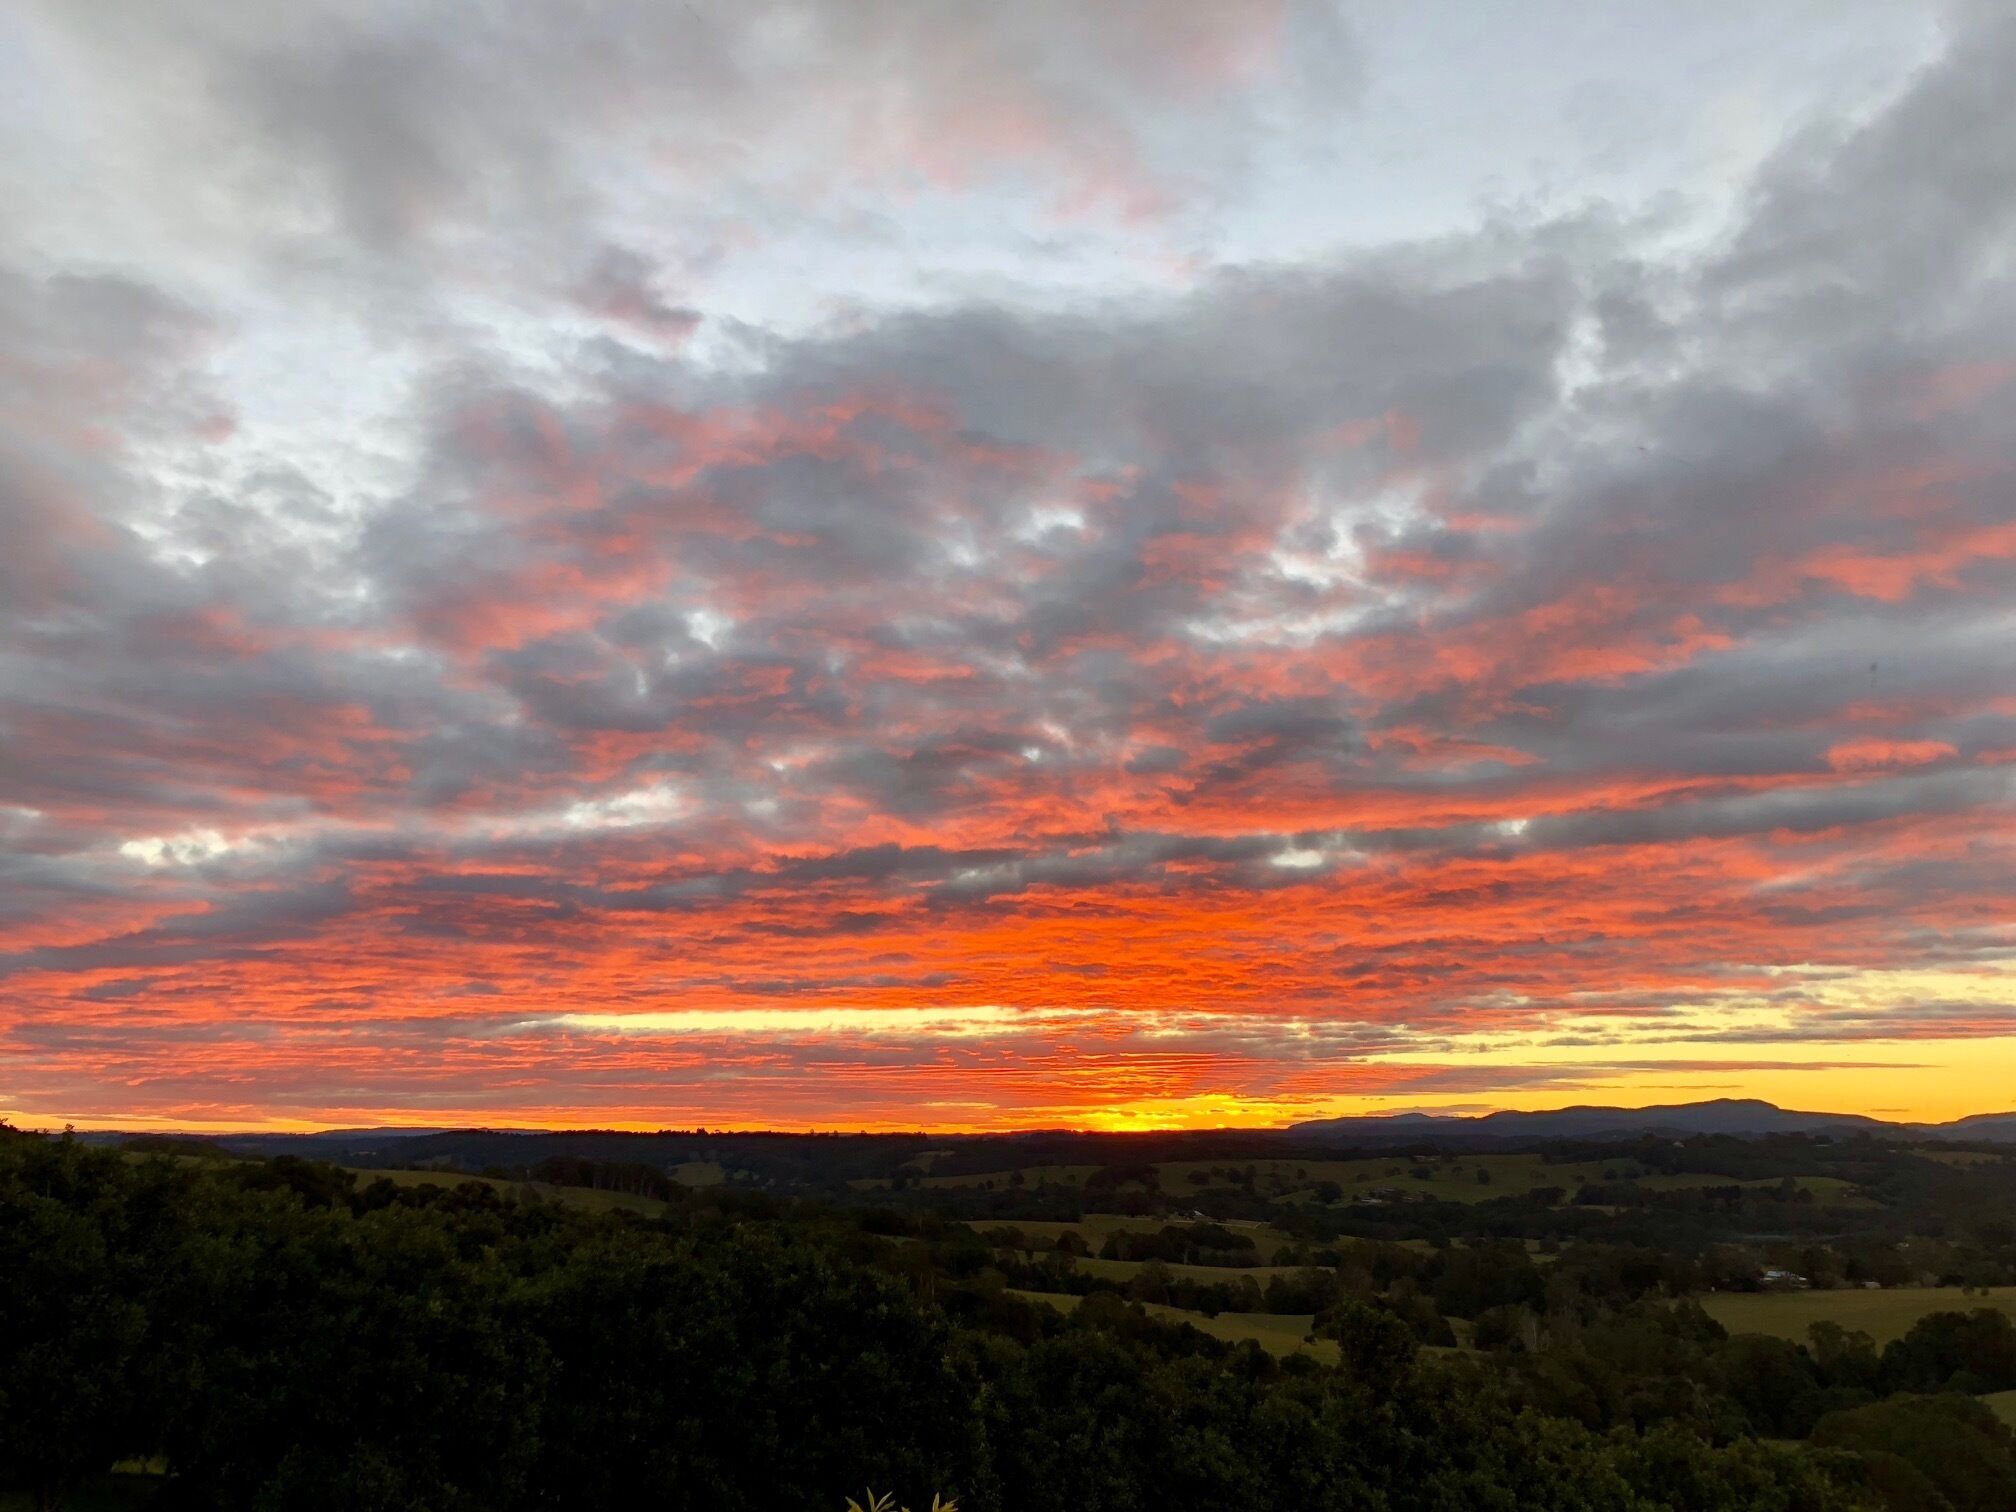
[{"left": 1286, "top": 1097, "right": 2016, "bottom": 1143}]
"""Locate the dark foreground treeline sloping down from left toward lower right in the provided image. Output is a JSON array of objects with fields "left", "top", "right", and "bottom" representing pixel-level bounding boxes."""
[{"left": 0, "top": 1133, "right": 1919, "bottom": 1512}]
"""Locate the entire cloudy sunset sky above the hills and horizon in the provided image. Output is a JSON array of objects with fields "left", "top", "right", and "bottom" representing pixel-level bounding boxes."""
[{"left": 0, "top": 0, "right": 2016, "bottom": 1129}]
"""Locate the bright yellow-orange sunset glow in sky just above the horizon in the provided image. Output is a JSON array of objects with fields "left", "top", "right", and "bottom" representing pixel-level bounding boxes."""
[{"left": 19, "top": 962, "right": 2016, "bottom": 1133}]
